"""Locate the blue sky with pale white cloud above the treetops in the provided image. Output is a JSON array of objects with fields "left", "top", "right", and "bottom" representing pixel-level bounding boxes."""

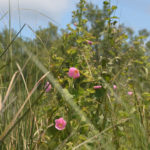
[{"left": 0, "top": 0, "right": 150, "bottom": 37}]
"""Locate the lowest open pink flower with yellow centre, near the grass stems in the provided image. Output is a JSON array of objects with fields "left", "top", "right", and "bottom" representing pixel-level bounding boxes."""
[{"left": 55, "top": 118, "right": 67, "bottom": 130}]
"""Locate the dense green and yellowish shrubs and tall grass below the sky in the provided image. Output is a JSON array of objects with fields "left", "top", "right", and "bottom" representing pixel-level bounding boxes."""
[{"left": 0, "top": 0, "right": 150, "bottom": 150}]
